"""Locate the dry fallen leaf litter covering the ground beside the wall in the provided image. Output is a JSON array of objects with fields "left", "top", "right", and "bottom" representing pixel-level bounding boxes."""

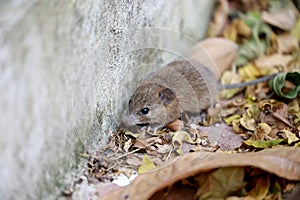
[{"left": 72, "top": 0, "right": 300, "bottom": 200}]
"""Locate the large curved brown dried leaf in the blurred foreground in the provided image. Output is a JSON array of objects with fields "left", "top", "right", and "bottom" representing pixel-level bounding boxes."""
[{"left": 101, "top": 147, "right": 300, "bottom": 200}]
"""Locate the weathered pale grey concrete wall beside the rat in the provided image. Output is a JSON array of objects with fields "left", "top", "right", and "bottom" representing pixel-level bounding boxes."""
[{"left": 0, "top": 0, "right": 213, "bottom": 199}]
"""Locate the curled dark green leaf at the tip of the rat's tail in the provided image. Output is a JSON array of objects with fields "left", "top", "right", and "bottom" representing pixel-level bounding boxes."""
[{"left": 269, "top": 72, "right": 300, "bottom": 99}]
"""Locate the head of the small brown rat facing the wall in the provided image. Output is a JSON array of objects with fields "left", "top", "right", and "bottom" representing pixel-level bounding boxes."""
[{"left": 122, "top": 83, "right": 180, "bottom": 126}]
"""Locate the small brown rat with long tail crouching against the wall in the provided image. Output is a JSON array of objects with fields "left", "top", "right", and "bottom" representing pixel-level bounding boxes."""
[{"left": 122, "top": 60, "right": 276, "bottom": 131}]
